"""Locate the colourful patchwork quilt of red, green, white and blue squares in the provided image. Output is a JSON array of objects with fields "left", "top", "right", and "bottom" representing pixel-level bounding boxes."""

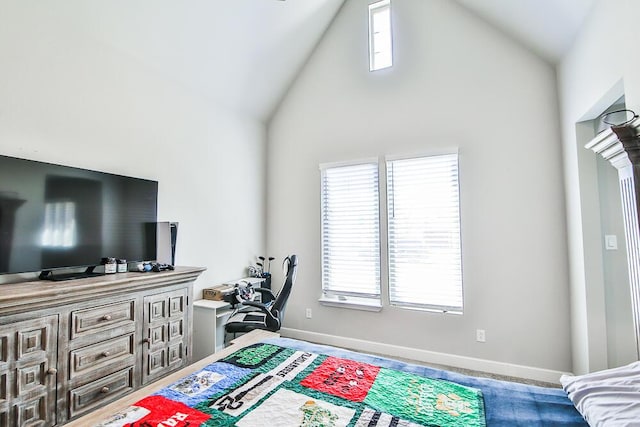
[{"left": 100, "top": 342, "right": 486, "bottom": 427}]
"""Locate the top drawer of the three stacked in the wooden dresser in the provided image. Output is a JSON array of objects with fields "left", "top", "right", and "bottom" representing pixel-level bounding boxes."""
[{"left": 71, "top": 300, "right": 135, "bottom": 339}]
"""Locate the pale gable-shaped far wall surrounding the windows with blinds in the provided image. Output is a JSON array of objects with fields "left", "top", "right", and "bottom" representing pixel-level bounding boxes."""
[{"left": 267, "top": 0, "right": 571, "bottom": 371}]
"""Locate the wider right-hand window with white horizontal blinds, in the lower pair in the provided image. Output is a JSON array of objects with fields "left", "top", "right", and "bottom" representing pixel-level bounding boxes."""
[{"left": 387, "top": 154, "right": 462, "bottom": 311}]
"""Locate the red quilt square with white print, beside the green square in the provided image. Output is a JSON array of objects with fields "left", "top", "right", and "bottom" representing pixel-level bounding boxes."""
[{"left": 300, "top": 357, "right": 380, "bottom": 402}]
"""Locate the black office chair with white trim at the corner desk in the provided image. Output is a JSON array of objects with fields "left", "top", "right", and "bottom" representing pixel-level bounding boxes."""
[{"left": 225, "top": 255, "right": 298, "bottom": 336}]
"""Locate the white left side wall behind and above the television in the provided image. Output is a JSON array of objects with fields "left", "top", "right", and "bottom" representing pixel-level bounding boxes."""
[{"left": 0, "top": 2, "right": 266, "bottom": 297}]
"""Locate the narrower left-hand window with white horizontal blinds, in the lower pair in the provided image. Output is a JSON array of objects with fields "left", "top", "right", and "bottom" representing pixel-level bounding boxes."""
[{"left": 322, "top": 163, "right": 380, "bottom": 298}]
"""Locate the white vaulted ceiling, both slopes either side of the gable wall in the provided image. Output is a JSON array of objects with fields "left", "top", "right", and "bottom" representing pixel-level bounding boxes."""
[{"left": 10, "top": 0, "right": 595, "bottom": 120}]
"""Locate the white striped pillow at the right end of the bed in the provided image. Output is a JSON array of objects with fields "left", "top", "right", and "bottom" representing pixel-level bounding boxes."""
[{"left": 560, "top": 362, "right": 640, "bottom": 427}]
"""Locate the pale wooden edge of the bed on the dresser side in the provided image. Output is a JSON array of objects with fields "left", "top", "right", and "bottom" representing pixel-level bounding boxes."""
[{"left": 64, "top": 330, "right": 280, "bottom": 427}]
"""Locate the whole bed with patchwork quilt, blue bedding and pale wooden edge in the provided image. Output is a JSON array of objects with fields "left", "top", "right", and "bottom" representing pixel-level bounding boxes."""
[{"left": 68, "top": 331, "right": 587, "bottom": 427}]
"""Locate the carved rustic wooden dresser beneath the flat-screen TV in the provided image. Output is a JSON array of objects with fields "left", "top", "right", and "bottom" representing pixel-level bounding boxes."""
[{"left": 0, "top": 267, "right": 204, "bottom": 426}]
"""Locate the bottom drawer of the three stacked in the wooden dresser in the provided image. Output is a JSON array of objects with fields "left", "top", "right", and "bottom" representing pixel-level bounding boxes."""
[{"left": 69, "top": 366, "right": 133, "bottom": 417}]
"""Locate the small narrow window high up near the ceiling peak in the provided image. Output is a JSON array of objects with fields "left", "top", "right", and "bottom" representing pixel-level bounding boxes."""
[{"left": 369, "top": 0, "right": 393, "bottom": 71}]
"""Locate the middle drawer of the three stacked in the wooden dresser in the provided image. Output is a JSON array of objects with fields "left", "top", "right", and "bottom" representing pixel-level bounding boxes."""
[{"left": 69, "top": 333, "right": 135, "bottom": 379}]
